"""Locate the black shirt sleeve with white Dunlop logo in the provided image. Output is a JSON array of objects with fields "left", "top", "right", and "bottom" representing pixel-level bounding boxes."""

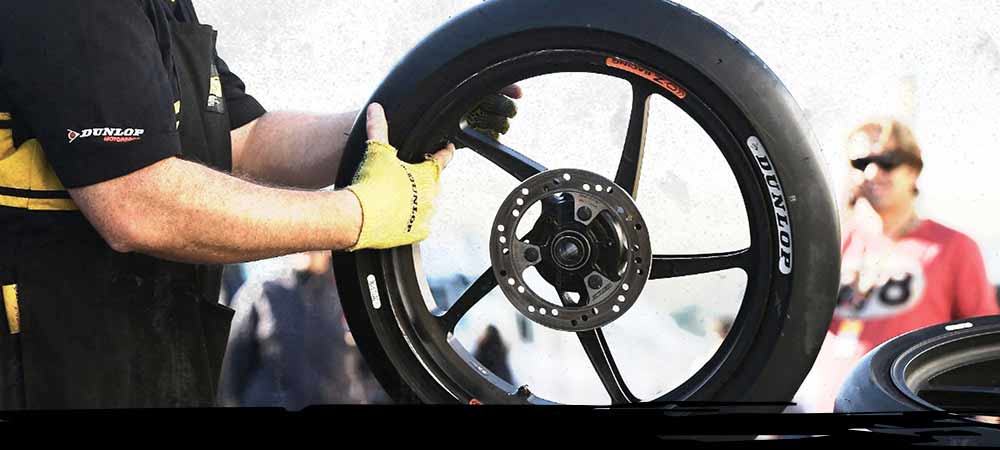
[{"left": 0, "top": 0, "right": 180, "bottom": 188}]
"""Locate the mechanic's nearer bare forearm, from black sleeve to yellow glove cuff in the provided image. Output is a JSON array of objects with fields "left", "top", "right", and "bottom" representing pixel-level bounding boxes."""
[{"left": 71, "top": 158, "right": 361, "bottom": 264}]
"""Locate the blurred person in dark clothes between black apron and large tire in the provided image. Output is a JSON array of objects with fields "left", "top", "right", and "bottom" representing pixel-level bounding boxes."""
[{"left": 219, "top": 251, "right": 388, "bottom": 410}]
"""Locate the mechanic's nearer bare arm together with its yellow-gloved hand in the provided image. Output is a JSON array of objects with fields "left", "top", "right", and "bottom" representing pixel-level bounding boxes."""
[{"left": 69, "top": 104, "right": 454, "bottom": 264}]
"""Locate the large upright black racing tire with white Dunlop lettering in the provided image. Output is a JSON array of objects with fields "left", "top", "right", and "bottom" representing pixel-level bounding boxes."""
[{"left": 334, "top": 0, "right": 840, "bottom": 411}]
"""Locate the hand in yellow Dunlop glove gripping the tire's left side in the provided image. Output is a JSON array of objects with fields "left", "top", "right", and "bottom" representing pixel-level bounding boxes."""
[{"left": 347, "top": 103, "right": 455, "bottom": 251}]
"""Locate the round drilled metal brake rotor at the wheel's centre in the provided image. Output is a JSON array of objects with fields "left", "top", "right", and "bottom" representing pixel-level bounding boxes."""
[{"left": 490, "top": 169, "right": 652, "bottom": 332}]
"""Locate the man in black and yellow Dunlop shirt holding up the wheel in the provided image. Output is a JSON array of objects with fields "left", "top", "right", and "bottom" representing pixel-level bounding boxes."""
[{"left": 0, "top": 0, "right": 516, "bottom": 409}]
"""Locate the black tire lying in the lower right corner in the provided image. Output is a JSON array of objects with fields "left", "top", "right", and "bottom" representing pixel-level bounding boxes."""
[{"left": 834, "top": 315, "right": 1000, "bottom": 415}]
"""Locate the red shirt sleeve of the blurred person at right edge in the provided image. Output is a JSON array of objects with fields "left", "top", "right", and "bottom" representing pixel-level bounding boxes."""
[{"left": 951, "top": 235, "right": 1000, "bottom": 319}]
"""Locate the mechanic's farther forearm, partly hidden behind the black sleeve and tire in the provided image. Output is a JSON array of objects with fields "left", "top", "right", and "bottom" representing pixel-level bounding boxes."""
[{"left": 232, "top": 111, "right": 357, "bottom": 189}]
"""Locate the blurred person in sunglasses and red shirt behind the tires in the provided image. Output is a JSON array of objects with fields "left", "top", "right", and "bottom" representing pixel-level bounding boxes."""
[{"left": 793, "top": 119, "right": 1000, "bottom": 412}]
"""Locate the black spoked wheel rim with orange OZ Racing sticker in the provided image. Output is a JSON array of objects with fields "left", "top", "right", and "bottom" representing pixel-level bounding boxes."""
[{"left": 352, "top": 31, "right": 777, "bottom": 404}]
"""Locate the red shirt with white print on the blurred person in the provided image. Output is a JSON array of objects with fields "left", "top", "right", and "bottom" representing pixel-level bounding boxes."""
[{"left": 830, "top": 220, "right": 1000, "bottom": 354}]
